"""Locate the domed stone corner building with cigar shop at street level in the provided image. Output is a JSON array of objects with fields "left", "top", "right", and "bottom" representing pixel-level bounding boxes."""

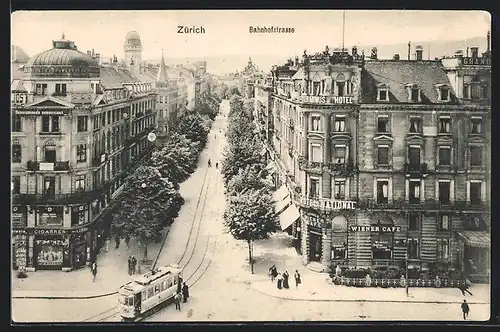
[{"left": 11, "top": 36, "right": 156, "bottom": 271}]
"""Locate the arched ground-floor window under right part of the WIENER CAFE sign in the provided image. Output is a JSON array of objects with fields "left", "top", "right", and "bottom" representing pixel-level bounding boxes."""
[{"left": 371, "top": 216, "right": 394, "bottom": 260}]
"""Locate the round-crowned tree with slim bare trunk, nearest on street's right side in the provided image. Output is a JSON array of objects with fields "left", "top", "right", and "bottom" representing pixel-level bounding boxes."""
[{"left": 224, "top": 188, "right": 278, "bottom": 274}]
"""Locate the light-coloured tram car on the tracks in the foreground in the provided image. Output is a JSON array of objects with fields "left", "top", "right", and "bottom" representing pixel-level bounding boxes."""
[{"left": 118, "top": 264, "right": 182, "bottom": 321}]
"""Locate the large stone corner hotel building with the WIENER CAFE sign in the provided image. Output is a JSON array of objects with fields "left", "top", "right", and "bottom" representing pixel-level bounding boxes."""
[{"left": 256, "top": 40, "right": 491, "bottom": 278}]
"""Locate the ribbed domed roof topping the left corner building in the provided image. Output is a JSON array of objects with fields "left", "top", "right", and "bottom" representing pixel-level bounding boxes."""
[{"left": 26, "top": 39, "right": 99, "bottom": 68}]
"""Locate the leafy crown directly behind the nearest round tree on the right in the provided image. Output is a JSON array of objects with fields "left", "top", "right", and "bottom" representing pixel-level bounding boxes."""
[{"left": 227, "top": 164, "right": 272, "bottom": 196}]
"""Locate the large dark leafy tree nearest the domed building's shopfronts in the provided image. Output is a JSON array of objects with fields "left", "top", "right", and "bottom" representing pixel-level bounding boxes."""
[{"left": 111, "top": 166, "right": 183, "bottom": 260}]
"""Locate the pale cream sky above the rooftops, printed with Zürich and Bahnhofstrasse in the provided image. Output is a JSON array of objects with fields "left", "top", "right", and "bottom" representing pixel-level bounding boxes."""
[{"left": 11, "top": 10, "right": 491, "bottom": 70}]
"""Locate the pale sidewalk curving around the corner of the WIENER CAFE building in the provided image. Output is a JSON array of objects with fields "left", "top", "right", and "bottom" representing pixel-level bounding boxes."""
[{"left": 249, "top": 234, "right": 490, "bottom": 304}]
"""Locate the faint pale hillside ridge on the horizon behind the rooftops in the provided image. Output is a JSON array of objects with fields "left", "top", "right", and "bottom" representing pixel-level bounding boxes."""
[{"left": 147, "top": 37, "right": 486, "bottom": 75}]
